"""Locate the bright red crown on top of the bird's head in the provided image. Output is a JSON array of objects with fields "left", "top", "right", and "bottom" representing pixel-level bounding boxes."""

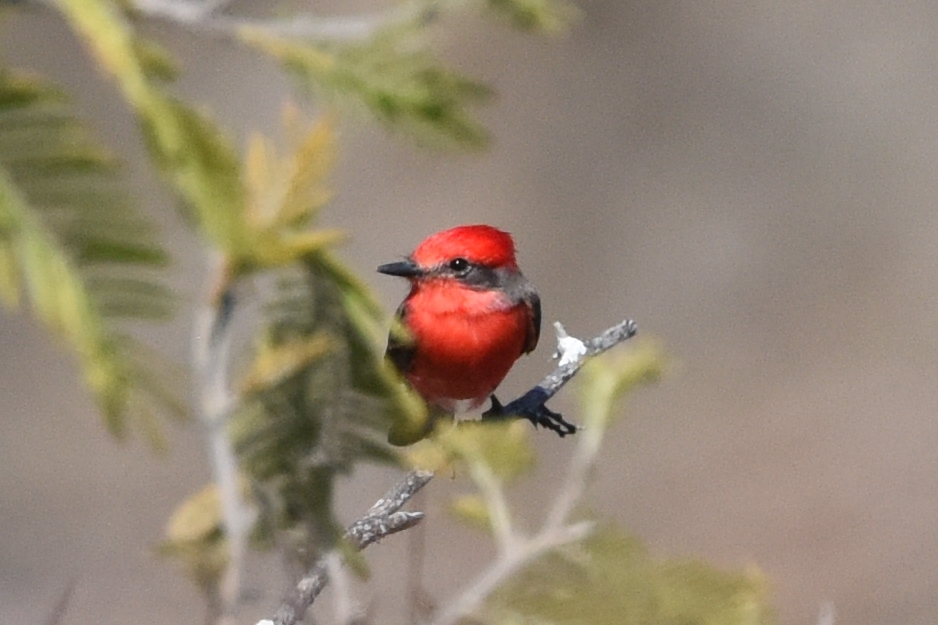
[{"left": 411, "top": 224, "right": 518, "bottom": 269}]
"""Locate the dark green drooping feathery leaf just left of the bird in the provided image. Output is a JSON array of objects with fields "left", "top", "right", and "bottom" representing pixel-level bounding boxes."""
[{"left": 230, "top": 252, "right": 412, "bottom": 565}]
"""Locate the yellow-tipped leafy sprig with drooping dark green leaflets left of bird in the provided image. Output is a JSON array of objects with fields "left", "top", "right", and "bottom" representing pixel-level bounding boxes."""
[{"left": 221, "top": 116, "right": 418, "bottom": 564}]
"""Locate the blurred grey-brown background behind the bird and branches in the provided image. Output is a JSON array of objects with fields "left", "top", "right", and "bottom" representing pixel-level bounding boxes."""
[{"left": 0, "top": 0, "right": 938, "bottom": 625}]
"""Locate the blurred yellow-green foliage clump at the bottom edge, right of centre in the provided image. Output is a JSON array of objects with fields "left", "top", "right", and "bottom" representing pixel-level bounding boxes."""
[{"left": 482, "top": 526, "right": 774, "bottom": 625}]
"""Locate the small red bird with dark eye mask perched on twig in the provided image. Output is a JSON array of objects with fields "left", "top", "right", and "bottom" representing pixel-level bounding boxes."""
[{"left": 378, "top": 225, "right": 541, "bottom": 414}]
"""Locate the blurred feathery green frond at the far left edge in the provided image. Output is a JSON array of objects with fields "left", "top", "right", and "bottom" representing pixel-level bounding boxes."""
[{"left": 0, "top": 70, "right": 185, "bottom": 444}]
